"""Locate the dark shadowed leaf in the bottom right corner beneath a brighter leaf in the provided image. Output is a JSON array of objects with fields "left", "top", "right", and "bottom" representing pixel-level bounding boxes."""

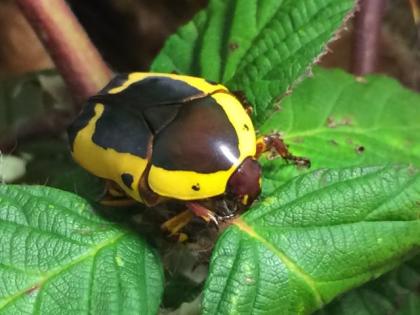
[{"left": 316, "top": 256, "right": 420, "bottom": 315}]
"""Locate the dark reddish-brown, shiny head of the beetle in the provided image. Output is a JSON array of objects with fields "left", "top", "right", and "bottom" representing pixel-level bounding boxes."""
[{"left": 227, "top": 157, "right": 261, "bottom": 207}]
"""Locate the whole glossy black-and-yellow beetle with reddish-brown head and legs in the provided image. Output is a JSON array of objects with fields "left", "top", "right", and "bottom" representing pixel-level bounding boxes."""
[{"left": 68, "top": 72, "right": 308, "bottom": 233}]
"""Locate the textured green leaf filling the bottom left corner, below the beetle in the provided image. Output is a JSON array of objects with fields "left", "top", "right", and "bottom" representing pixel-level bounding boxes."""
[{"left": 0, "top": 185, "right": 163, "bottom": 314}]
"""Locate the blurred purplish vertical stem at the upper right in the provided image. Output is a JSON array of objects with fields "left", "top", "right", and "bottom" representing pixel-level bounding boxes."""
[{"left": 352, "top": 0, "right": 386, "bottom": 76}]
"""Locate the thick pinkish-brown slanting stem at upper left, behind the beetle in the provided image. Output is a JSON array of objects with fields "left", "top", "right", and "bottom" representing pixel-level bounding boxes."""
[{"left": 16, "top": 0, "right": 112, "bottom": 106}]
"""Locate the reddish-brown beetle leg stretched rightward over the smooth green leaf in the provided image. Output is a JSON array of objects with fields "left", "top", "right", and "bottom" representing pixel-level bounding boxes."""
[{"left": 255, "top": 134, "right": 311, "bottom": 168}]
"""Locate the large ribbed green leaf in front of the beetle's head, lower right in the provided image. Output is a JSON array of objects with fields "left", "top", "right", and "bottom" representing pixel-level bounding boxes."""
[{"left": 203, "top": 167, "right": 420, "bottom": 314}]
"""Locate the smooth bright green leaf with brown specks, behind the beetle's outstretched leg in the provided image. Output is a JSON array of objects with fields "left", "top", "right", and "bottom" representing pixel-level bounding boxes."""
[{"left": 260, "top": 68, "right": 420, "bottom": 193}]
